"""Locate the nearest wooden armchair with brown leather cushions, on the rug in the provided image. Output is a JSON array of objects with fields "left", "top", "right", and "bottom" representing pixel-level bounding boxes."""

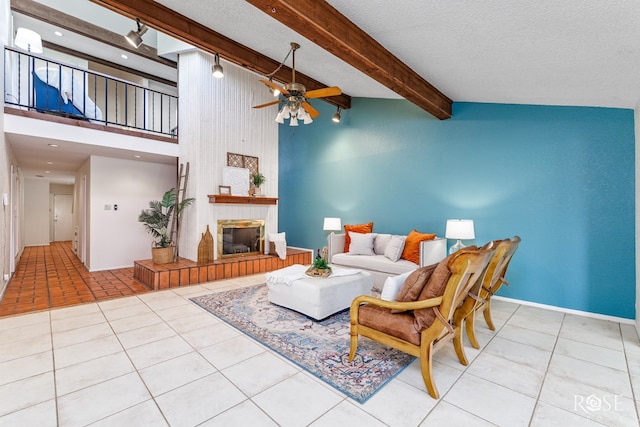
[{"left": 349, "top": 249, "right": 493, "bottom": 399}]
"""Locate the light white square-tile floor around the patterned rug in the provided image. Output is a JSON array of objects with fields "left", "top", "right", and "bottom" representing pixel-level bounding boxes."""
[{"left": 0, "top": 275, "right": 640, "bottom": 427}]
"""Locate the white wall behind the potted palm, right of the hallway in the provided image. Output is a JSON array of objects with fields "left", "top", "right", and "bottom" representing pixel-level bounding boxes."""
[{"left": 86, "top": 156, "right": 176, "bottom": 271}]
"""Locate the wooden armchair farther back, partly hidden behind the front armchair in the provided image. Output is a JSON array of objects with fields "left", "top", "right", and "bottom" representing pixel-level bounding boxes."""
[{"left": 453, "top": 236, "right": 520, "bottom": 352}]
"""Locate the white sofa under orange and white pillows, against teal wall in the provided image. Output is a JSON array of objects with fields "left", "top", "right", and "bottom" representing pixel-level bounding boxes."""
[{"left": 327, "top": 233, "right": 447, "bottom": 292}]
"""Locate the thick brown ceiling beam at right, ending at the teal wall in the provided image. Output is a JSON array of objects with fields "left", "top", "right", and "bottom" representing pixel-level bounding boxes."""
[{"left": 246, "top": 0, "right": 452, "bottom": 119}]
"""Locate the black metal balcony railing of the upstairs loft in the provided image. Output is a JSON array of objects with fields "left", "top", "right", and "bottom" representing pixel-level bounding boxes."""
[{"left": 4, "top": 47, "right": 178, "bottom": 137}]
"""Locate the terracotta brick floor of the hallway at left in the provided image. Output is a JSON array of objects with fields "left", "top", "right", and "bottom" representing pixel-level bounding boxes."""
[{"left": 0, "top": 242, "right": 151, "bottom": 316}]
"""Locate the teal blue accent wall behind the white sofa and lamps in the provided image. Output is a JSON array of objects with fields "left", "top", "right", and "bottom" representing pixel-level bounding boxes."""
[{"left": 279, "top": 98, "right": 635, "bottom": 319}]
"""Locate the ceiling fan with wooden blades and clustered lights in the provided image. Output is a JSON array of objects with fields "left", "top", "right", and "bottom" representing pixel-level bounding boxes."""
[{"left": 253, "top": 42, "right": 342, "bottom": 126}]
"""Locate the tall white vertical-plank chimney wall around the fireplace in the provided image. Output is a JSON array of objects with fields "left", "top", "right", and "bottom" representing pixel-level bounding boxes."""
[{"left": 178, "top": 51, "right": 278, "bottom": 261}]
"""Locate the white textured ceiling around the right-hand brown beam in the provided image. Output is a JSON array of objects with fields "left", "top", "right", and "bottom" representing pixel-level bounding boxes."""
[{"left": 158, "top": 0, "right": 640, "bottom": 108}]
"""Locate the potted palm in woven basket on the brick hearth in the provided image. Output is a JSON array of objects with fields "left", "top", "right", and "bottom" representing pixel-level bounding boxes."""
[{"left": 138, "top": 188, "right": 194, "bottom": 264}]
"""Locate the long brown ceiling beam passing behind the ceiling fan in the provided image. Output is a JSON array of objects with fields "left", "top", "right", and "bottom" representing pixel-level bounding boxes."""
[{"left": 91, "top": 0, "right": 351, "bottom": 109}]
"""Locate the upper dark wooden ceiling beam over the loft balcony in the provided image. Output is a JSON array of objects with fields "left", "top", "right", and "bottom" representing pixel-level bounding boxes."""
[{"left": 11, "top": 0, "right": 176, "bottom": 68}]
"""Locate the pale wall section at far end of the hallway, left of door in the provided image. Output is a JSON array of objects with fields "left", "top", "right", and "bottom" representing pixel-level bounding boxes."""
[{"left": 24, "top": 179, "right": 49, "bottom": 246}]
